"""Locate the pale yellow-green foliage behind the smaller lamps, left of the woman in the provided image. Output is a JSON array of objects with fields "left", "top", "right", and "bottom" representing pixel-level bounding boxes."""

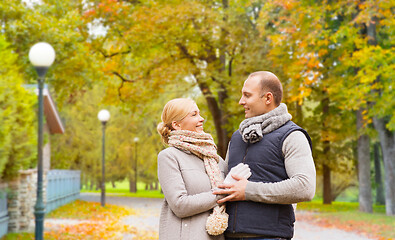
[{"left": 51, "top": 84, "right": 168, "bottom": 188}]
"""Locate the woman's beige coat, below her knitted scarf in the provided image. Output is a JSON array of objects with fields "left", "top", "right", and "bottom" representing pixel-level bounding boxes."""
[{"left": 158, "top": 147, "right": 226, "bottom": 240}]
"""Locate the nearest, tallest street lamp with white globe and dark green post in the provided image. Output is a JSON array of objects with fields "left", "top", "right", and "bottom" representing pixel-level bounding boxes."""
[{"left": 29, "top": 42, "right": 55, "bottom": 240}]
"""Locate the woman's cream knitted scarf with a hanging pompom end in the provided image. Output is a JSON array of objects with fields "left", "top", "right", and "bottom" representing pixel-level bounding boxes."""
[{"left": 169, "top": 130, "right": 228, "bottom": 235}]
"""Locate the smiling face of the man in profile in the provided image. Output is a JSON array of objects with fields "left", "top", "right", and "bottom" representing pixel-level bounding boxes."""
[{"left": 239, "top": 77, "right": 268, "bottom": 118}]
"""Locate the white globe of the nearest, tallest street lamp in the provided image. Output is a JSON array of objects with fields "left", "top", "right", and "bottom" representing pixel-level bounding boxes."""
[{"left": 29, "top": 42, "right": 55, "bottom": 67}]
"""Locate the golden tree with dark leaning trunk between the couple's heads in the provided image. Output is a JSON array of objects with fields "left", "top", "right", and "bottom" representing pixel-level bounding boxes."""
[{"left": 85, "top": 1, "right": 278, "bottom": 156}]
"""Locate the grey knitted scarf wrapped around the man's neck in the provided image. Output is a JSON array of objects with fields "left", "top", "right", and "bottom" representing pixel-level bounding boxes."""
[{"left": 239, "top": 103, "right": 292, "bottom": 143}]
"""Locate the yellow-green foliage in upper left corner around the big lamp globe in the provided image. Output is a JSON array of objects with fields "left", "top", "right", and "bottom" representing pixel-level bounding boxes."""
[{"left": 0, "top": 0, "right": 98, "bottom": 109}]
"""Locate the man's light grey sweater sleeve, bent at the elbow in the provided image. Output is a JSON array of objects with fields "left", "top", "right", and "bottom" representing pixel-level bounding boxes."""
[{"left": 245, "top": 131, "right": 316, "bottom": 204}]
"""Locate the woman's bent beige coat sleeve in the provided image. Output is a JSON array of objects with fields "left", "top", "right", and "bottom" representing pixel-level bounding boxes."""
[{"left": 158, "top": 151, "right": 220, "bottom": 218}]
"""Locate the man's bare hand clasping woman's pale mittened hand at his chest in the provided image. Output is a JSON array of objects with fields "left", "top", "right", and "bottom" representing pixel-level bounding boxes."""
[{"left": 213, "top": 163, "right": 251, "bottom": 204}]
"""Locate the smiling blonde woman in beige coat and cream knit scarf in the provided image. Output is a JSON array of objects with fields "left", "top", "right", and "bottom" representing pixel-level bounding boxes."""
[{"left": 158, "top": 98, "right": 228, "bottom": 240}]
